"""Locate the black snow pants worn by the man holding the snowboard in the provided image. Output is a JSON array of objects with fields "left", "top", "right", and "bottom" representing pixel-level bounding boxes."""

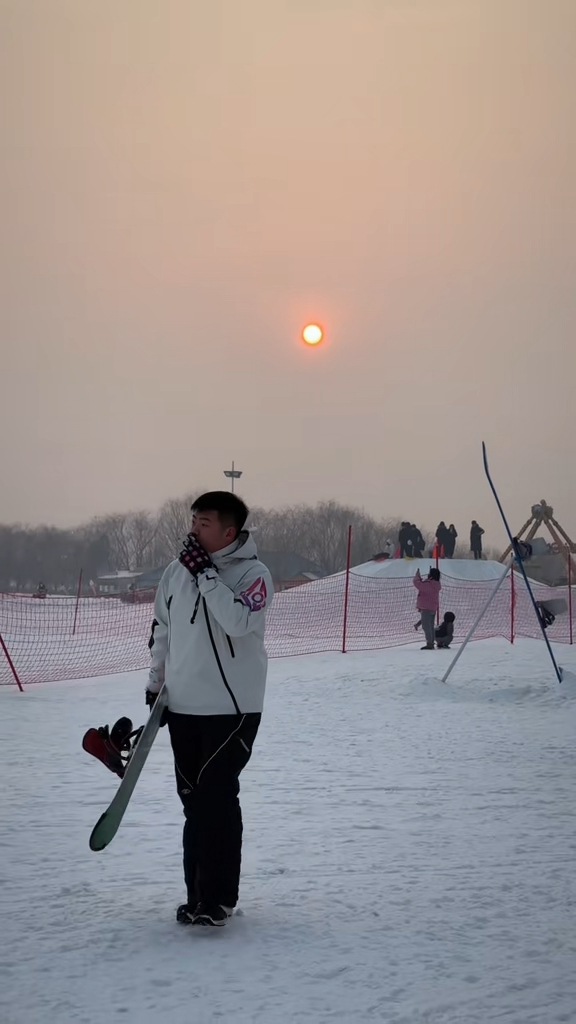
[{"left": 168, "top": 712, "right": 261, "bottom": 907}]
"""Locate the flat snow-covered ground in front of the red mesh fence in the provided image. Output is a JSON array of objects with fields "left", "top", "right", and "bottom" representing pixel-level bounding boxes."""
[{"left": 0, "top": 640, "right": 576, "bottom": 1024}]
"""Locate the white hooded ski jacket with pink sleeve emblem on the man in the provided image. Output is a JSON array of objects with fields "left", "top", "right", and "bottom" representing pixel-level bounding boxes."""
[{"left": 147, "top": 530, "right": 274, "bottom": 715}]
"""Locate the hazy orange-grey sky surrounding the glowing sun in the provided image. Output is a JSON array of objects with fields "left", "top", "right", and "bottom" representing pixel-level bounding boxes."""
[{"left": 0, "top": 0, "right": 576, "bottom": 545}]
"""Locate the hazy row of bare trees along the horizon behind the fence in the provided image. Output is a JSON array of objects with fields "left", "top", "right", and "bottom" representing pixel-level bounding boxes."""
[{"left": 0, "top": 493, "right": 485, "bottom": 594}]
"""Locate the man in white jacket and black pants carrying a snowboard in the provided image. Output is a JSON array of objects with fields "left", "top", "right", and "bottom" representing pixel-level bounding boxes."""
[{"left": 147, "top": 490, "right": 274, "bottom": 926}]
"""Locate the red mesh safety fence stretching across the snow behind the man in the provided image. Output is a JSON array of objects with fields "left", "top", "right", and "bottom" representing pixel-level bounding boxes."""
[{"left": 0, "top": 571, "right": 574, "bottom": 685}]
